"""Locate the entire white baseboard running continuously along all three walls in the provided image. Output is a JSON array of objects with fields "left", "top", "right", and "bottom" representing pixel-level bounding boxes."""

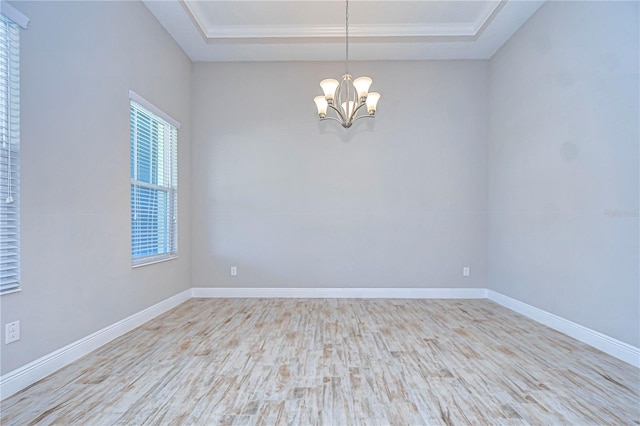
[{"left": 0, "top": 287, "right": 640, "bottom": 400}]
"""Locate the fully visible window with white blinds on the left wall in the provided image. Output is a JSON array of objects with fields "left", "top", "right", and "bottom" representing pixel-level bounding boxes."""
[{"left": 129, "top": 92, "right": 180, "bottom": 266}]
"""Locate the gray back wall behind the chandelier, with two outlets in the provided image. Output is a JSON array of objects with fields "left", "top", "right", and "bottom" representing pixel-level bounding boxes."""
[{"left": 192, "top": 61, "right": 488, "bottom": 288}]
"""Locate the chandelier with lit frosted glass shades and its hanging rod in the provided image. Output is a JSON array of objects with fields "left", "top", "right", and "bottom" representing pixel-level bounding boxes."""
[{"left": 313, "top": 0, "right": 380, "bottom": 129}]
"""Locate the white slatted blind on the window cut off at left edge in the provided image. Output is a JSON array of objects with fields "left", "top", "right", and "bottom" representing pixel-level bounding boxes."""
[{"left": 0, "top": 15, "right": 20, "bottom": 294}]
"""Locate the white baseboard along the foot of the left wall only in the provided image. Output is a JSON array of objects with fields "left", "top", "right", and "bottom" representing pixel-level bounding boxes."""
[{"left": 0, "top": 289, "right": 192, "bottom": 400}]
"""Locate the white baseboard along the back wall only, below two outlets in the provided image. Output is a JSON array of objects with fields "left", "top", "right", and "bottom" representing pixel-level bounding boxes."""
[{"left": 192, "top": 287, "right": 487, "bottom": 299}]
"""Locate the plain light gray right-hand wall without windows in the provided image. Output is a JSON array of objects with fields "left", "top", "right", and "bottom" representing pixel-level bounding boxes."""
[{"left": 488, "top": 2, "right": 640, "bottom": 346}]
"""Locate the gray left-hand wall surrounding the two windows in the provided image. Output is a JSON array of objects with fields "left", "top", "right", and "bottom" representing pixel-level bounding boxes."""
[{"left": 0, "top": 2, "right": 191, "bottom": 374}]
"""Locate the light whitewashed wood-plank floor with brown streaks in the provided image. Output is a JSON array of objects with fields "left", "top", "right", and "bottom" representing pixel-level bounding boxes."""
[{"left": 1, "top": 299, "right": 640, "bottom": 425}]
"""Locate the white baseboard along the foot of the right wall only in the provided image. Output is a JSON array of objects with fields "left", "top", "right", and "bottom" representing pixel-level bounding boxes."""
[{"left": 487, "top": 290, "right": 640, "bottom": 368}]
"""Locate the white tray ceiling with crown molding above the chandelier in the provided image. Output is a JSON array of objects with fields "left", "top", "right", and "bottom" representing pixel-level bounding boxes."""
[{"left": 144, "top": 0, "right": 544, "bottom": 62}]
